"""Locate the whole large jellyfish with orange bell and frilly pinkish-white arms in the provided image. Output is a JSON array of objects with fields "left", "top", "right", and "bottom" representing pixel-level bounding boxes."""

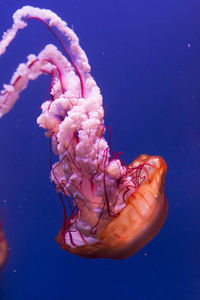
[{"left": 0, "top": 6, "right": 168, "bottom": 259}]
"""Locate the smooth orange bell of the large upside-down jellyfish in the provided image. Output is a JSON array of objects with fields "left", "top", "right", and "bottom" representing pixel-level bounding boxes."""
[{"left": 57, "top": 155, "right": 168, "bottom": 259}]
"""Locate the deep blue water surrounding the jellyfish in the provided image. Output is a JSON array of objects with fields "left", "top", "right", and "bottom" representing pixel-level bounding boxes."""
[{"left": 0, "top": 0, "right": 200, "bottom": 300}]
